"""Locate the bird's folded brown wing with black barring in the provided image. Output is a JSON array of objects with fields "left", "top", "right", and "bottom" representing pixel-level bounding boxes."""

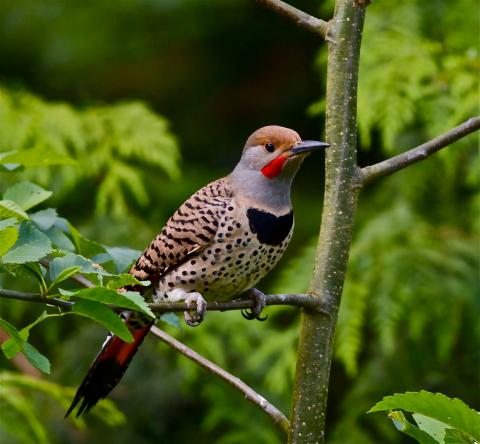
[{"left": 130, "top": 179, "right": 232, "bottom": 283}]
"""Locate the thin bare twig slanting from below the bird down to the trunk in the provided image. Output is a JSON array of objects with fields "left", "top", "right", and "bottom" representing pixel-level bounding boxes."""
[{"left": 151, "top": 326, "right": 290, "bottom": 434}]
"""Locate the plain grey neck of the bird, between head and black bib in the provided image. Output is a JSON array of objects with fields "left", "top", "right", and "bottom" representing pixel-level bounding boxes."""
[{"left": 227, "top": 165, "right": 293, "bottom": 215}]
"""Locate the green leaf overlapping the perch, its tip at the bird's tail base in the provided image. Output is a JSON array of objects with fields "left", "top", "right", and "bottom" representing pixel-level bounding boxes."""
[{"left": 74, "top": 287, "right": 155, "bottom": 318}]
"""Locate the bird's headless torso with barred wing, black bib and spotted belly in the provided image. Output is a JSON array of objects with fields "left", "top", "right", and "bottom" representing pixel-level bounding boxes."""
[{"left": 141, "top": 178, "right": 293, "bottom": 301}]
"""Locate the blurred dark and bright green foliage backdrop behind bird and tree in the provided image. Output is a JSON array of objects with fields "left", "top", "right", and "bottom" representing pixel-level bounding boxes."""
[{"left": 0, "top": 0, "right": 480, "bottom": 444}]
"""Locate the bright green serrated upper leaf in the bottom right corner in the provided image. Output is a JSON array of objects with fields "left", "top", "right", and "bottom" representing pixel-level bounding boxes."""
[{"left": 369, "top": 390, "right": 480, "bottom": 441}]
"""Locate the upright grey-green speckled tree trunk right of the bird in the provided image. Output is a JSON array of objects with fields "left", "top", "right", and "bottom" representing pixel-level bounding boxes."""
[{"left": 289, "top": 0, "right": 365, "bottom": 444}]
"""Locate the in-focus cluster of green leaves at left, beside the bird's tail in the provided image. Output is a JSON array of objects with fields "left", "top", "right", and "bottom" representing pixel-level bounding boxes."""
[{"left": 0, "top": 182, "right": 155, "bottom": 373}]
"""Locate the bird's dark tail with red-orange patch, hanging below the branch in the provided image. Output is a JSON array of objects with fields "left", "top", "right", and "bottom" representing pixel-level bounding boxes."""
[{"left": 65, "top": 313, "right": 153, "bottom": 418}]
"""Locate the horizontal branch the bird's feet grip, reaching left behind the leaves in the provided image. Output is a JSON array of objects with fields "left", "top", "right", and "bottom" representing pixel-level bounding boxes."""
[{"left": 0, "top": 290, "right": 322, "bottom": 314}]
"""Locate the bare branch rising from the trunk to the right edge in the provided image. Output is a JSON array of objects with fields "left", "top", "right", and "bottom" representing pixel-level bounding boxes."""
[{"left": 361, "top": 116, "right": 480, "bottom": 184}]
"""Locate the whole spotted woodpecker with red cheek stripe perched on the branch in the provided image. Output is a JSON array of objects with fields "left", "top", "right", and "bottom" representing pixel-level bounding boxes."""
[{"left": 65, "top": 125, "right": 329, "bottom": 417}]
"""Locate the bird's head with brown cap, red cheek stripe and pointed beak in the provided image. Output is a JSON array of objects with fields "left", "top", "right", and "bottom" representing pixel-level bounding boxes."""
[{"left": 239, "top": 125, "right": 329, "bottom": 180}]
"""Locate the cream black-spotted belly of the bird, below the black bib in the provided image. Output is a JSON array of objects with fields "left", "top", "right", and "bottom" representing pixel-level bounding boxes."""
[{"left": 156, "top": 230, "right": 293, "bottom": 302}]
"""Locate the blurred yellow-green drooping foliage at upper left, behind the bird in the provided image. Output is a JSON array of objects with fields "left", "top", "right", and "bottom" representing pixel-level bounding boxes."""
[{"left": 0, "top": 87, "right": 179, "bottom": 217}]
